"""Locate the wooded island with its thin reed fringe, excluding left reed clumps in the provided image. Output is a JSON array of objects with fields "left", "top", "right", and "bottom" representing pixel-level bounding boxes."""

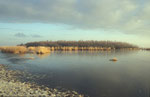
[{"left": 22, "top": 40, "right": 138, "bottom": 51}]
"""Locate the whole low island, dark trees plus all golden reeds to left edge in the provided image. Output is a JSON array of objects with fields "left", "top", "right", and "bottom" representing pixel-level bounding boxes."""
[{"left": 0, "top": 40, "right": 139, "bottom": 54}]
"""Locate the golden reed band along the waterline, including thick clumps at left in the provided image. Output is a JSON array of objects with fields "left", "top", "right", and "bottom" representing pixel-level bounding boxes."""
[{"left": 0, "top": 46, "right": 138, "bottom": 54}]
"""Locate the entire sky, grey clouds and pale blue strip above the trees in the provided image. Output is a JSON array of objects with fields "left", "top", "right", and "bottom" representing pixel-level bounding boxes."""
[{"left": 0, "top": 0, "right": 150, "bottom": 47}]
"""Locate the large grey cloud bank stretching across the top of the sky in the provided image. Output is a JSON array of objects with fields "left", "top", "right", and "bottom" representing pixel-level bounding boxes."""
[{"left": 0, "top": 0, "right": 150, "bottom": 35}]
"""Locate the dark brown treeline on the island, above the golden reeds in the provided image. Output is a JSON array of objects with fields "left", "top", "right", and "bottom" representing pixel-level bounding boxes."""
[{"left": 21, "top": 40, "right": 138, "bottom": 49}]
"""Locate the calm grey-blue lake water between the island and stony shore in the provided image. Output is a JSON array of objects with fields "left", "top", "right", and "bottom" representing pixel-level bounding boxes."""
[{"left": 0, "top": 51, "right": 150, "bottom": 97}]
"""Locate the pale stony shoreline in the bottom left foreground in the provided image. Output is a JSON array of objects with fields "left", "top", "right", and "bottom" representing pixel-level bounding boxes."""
[{"left": 0, "top": 64, "right": 84, "bottom": 97}]
